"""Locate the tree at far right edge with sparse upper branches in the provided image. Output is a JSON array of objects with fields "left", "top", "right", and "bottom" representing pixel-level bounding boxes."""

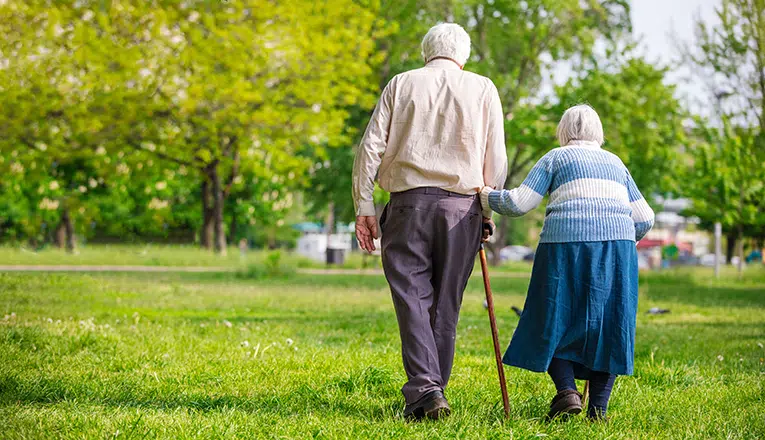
[{"left": 680, "top": 0, "right": 765, "bottom": 269}]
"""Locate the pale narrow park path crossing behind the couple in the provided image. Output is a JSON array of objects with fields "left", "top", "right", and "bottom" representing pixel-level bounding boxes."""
[{"left": 0, "top": 264, "right": 529, "bottom": 278}]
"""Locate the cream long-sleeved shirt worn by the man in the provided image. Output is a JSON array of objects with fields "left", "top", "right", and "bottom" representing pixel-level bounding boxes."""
[{"left": 353, "top": 59, "right": 507, "bottom": 217}]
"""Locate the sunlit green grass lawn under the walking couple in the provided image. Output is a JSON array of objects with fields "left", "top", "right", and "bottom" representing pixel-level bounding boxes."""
[{"left": 0, "top": 263, "right": 765, "bottom": 439}]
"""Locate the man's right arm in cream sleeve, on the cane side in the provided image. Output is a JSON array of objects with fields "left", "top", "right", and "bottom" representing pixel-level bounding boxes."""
[{"left": 481, "top": 84, "right": 507, "bottom": 218}]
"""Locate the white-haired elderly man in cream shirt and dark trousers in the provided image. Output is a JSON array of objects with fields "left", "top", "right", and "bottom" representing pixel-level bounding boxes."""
[{"left": 353, "top": 23, "right": 507, "bottom": 419}]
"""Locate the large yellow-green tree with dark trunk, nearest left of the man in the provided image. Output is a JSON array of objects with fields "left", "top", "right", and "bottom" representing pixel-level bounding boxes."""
[{"left": 105, "top": 0, "right": 382, "bottom": 253}]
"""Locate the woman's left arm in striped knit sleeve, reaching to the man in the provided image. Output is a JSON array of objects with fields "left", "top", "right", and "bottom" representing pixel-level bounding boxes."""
[{"left": 481, "top": 150, "right": 555, "bottom": 217}]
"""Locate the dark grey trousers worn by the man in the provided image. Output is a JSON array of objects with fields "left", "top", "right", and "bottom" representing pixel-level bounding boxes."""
[{"left": 380, "top": 188, "right": 482, "bottom": 405}]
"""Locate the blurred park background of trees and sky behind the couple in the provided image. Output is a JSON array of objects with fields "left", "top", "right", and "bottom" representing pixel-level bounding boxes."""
[{"left": 0, "top": 0, "right": 765, "bottom": 270}]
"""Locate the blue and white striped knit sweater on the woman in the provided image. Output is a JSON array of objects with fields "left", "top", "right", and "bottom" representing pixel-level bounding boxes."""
[{"left": 481, "top": 141, "right": 654, "bottom": 243}]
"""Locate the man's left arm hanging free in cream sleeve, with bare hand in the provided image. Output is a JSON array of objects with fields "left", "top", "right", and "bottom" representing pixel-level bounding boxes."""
[{"left": 353, "top": 83, "right": 393, "bottom": 252}]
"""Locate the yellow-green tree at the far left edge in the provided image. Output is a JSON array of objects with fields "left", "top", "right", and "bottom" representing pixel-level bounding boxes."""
[{"left": 0, "top": 2, "right": 119, "bottom": 251}]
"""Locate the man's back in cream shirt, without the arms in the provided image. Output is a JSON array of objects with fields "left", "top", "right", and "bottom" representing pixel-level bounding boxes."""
[{"left": 379, "top": 60, "right": 504, "bottom": 194}]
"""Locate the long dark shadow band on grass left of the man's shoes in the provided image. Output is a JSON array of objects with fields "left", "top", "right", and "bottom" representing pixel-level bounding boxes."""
[{"left": 0, "top": 367, "right": 403, "bottom": 421}]
